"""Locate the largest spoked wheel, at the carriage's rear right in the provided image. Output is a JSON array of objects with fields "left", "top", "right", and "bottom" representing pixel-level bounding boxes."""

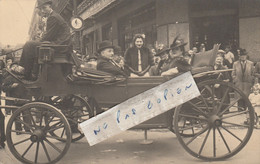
[{"left": 174, "top": 80, "right": 254, "bottom": 160}]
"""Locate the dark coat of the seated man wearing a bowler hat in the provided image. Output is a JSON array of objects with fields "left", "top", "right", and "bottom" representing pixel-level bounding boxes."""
[{"left": 97, "top": 57, "right": 126, "bottom": 76}]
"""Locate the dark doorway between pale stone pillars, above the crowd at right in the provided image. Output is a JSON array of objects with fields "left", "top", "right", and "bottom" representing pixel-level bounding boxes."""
[{"left": 191, "top": 15, "right": 239, "bottom": 50}]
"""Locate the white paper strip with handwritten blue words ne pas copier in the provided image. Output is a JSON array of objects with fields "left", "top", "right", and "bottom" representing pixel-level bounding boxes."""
[{"left": 80, "top": 72, "right": 200, "bottom": 146}]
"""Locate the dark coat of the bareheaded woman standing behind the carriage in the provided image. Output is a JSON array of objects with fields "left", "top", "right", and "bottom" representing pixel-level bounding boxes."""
[{"left": 124, "top": 47, "right": 154, "bottom": 71}]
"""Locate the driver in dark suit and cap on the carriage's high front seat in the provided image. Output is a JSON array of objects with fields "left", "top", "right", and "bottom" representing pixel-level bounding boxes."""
[{"left": 19, "top": 0, "right": 71, "bottom": 79}]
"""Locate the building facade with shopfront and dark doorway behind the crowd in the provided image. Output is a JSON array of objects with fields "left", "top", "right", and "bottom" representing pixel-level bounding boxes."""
[{"left": 77, "top": 0, "right": 260, "bottom": 61}]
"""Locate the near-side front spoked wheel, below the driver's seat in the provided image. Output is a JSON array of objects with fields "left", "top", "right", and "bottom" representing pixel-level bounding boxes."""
[{"left": 6, "top": 102, "right": 71, "bottom": 163}]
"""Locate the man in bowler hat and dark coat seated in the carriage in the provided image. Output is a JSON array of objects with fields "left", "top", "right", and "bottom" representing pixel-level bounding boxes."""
[{"left": 97, "top": 40, "right": 126, "bottom": 76}]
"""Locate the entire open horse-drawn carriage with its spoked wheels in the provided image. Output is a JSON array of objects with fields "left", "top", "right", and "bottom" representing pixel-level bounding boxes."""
[{"left": 1, "top": 45, "right": 254, "bottom": 163}]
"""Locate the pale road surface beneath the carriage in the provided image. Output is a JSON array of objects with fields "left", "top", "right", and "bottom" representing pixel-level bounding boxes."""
[{"left": 0, "top": 129, "right": 260, "bottom": 164}]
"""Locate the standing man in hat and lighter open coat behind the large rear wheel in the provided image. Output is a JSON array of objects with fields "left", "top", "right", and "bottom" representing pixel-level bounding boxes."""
[{"left": 232, "top": 49, "right": 254, "bottom": 110}]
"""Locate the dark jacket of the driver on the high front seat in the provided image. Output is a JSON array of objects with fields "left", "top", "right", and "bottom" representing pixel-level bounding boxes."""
[{"left": 42, "top": 11, "right": 71, "bottom": 45}]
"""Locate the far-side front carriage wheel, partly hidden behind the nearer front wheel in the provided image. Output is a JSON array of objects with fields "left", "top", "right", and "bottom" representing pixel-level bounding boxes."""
[{"left": 51, "top": 95, "right": 93, "bottom": 142}]
